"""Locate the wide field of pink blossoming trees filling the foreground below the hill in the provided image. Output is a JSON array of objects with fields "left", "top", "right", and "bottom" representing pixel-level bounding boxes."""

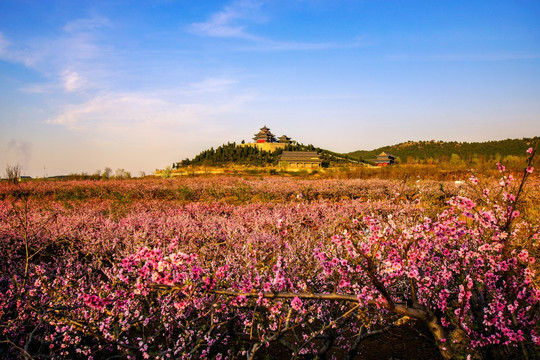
[{"left": 0, "top": 149, "right": 540, "bottom": 359}]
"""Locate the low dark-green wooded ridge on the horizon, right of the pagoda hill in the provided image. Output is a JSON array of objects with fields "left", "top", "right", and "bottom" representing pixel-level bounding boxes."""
[{"left": 345, "top": 136, "right": 540, "bottom": 163}]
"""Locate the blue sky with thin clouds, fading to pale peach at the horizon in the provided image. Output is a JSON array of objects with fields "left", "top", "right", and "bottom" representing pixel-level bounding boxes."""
[{"left": 0, "top": 0, "right": 540, "bottom": 176}]
